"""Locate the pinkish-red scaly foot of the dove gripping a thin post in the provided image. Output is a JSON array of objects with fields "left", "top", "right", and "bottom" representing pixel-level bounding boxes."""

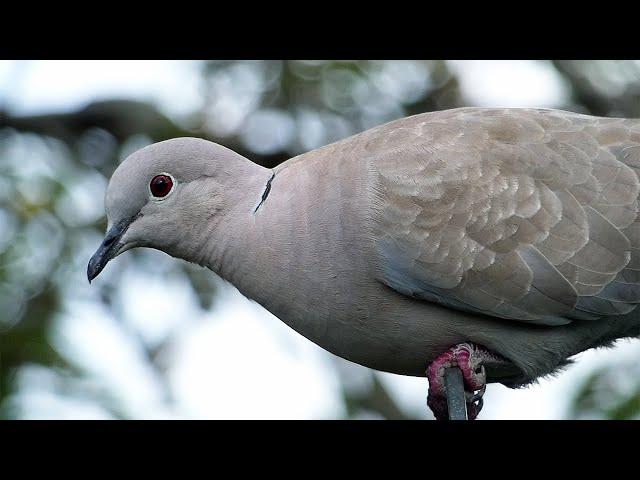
[{"left": 427, "top": 342, "right": 497, "bottom": 420}]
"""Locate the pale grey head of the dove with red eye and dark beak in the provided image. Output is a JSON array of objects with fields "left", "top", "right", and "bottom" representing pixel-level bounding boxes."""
[{"left": 87, "top": 137, "right": 255, "bottom": 282}]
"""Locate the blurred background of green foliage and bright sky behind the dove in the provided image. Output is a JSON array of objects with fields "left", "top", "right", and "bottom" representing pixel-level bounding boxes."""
[{"left": 0, "top": 60, "right": 640, "bottom": 419}]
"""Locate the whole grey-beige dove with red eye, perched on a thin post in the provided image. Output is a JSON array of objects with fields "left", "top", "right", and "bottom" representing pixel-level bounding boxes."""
[{"left": 88, "top": 108, "right": 640, "bottom": 418}]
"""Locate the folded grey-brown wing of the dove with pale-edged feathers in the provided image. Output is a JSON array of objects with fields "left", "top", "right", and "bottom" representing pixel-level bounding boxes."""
[{"left": 360, "top": 108, "right": 640, "bottom": 325}]
